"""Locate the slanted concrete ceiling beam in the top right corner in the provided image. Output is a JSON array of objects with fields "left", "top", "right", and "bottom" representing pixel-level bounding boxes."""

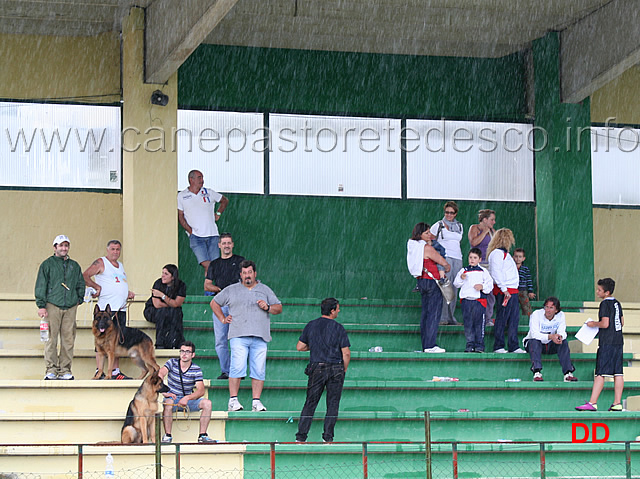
[{"left": 560, "top": 0, "right": 640, "bottom": 103}]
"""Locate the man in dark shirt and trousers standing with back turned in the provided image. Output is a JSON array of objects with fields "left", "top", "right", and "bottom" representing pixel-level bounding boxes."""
[{"left": 296, "top": 298, "right": 351, "bottom": 442}]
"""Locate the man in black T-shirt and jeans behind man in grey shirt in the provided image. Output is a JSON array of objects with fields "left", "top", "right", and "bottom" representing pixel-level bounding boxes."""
[{"left": 204, "top": 233, "right": 244, "bottom": 379}]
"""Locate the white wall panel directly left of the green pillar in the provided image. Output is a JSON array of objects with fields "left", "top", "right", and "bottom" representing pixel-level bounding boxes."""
[{"left": 405, "top": 120, "right": 534, "bottom": 201}]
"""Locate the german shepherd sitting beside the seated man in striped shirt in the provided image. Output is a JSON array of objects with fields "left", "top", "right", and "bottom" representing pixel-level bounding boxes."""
[{"left": 121, "top": 371, "right": 169, "bottom": 444}]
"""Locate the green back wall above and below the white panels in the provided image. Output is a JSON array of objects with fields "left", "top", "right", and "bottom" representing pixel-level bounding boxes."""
[{"left": 178, "top": 45, "right": 535, "bottom": 301}]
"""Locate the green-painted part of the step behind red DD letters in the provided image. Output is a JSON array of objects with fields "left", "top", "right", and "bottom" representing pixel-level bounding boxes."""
[{"left": 225, "top": 410, "right": 640, "bottom": 442}]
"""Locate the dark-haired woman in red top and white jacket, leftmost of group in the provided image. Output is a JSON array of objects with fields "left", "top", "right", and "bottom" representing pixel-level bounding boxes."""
[{"left": 407, "top": 223, "right": 450, "bottom": 353}]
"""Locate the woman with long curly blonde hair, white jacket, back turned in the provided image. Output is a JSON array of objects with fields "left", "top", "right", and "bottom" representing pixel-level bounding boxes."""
[{"left": 487, "top": 228, "right": 526, "bottom": 353}]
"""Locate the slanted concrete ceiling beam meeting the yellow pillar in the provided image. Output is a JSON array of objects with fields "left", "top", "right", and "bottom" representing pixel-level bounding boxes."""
[{"left": 144, "top": 0, "right": 238, "bottom": 83}]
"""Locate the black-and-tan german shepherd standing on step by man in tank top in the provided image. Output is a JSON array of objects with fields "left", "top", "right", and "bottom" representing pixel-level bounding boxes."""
[{"left": 92, "top": 304, "right": 160, "bottom": 379}]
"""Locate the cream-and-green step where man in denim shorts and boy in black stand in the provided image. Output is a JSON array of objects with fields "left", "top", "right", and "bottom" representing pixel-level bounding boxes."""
[{"left": 7, "top": 378, "right": 640, "bottom": 415}]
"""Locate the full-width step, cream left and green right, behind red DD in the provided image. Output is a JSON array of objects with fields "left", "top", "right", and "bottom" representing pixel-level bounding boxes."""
[{"left": 7, "top": 409, "right": 640, "bottom": 444}]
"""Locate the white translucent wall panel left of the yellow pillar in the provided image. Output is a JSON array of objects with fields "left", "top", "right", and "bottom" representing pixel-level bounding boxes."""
[{"left": 0, "top": 102, "right": 122, "bottom": 190}]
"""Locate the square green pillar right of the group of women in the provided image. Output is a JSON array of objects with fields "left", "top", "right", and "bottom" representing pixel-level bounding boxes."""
[{"left": 533, "top": 33, "right": 594, "bottom": 301}]
